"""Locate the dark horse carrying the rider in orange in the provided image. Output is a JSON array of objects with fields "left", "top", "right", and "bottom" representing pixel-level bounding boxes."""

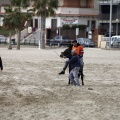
[{"left": 60, "top": 44, "right": 84, "bottom": 85}]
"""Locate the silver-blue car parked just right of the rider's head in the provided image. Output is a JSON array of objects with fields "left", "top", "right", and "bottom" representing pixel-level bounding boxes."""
[{"left": 77, "top": 38, "right": 95, "bottom": 47}]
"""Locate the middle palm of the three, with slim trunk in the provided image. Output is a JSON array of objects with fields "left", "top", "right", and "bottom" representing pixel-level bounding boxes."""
[{"left": 10, "top": 0, "right": 31, "bottom": 50}]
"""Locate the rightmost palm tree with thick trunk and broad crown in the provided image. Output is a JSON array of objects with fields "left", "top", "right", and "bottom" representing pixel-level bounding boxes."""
[{"left": 34, "top": 0, "right": 58, "bottom": 49}]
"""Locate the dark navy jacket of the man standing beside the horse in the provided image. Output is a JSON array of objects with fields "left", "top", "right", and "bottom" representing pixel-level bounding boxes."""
[{"left": 67, "top": 55, "right": 80, "bottom": 69}]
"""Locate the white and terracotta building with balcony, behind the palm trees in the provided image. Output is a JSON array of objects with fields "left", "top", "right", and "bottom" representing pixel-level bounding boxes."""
[{"left": 0, "top": 0, "right": 99, "bottom": 43}]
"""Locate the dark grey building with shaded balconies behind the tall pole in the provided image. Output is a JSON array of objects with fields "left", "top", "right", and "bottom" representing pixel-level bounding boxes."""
[{"left": 98, "top": 0, "right": 120, "bottom": 37}]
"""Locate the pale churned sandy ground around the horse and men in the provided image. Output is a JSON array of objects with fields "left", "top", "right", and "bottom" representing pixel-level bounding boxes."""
[{"left": 0, "top": 46, "right": 120, "bottom": 120}]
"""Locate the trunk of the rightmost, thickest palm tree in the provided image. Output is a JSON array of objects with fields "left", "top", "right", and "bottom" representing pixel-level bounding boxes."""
[{"left": 40, "top": 17, "right": 46, "bottom": 49}]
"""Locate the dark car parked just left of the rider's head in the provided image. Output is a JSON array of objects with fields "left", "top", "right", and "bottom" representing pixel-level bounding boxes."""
[{"left": 49, "top": 36, "right": 71, "bottom": 46}]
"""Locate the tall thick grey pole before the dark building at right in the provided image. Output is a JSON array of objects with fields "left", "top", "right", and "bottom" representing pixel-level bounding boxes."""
[{"left": 109, "top": 0, "right": 113, "bottom": 48}]
